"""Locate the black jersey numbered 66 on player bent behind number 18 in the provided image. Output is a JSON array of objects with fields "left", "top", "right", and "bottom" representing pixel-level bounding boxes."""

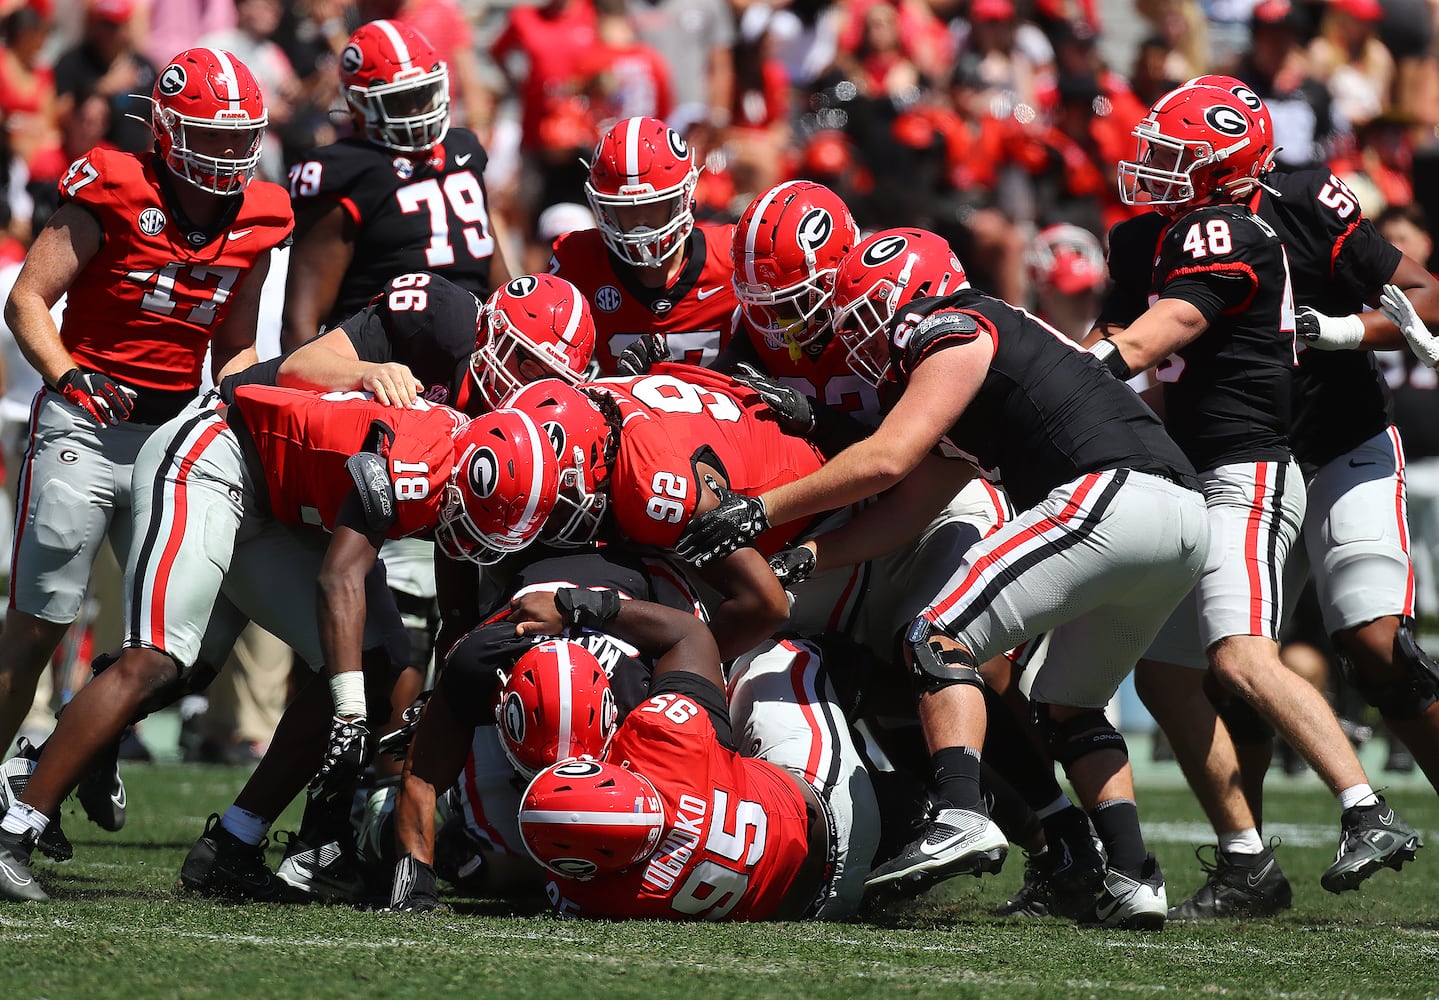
[{"left": 340, "top": 271, "right": 479, "bottom": 407}]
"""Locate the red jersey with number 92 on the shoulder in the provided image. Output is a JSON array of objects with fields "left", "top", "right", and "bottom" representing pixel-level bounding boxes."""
[{"left": 590, "top": 364, "right": 825, "bottom": 555}]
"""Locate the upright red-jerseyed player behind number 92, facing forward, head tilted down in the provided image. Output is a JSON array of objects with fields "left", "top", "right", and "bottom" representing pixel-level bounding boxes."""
[{"left": 550, "top": 118, "right": 735, "bottom": 376}]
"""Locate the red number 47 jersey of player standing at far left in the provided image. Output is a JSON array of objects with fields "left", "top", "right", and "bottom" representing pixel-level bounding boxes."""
[{"left": 60, "top": 148, "right": 295, "bottom": 393}]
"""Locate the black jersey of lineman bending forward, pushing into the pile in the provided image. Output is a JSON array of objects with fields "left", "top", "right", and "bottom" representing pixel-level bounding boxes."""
[{"left": 889, "top": 289, "right": 1197, "bottom": 508}]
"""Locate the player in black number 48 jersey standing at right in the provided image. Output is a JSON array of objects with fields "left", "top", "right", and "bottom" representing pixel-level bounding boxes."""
[{"left": 1091, "top": 83, "right": 1417, "bottom": 918}]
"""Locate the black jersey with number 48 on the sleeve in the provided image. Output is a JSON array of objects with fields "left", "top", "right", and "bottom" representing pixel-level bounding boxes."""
[{"left": 1099, "top": 204, "right": 1295, "bottom": 469}]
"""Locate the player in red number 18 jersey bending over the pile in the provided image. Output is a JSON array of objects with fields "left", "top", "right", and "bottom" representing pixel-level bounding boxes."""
[{"left": 0, "top": 384, "right": 557, "bottom": 901}]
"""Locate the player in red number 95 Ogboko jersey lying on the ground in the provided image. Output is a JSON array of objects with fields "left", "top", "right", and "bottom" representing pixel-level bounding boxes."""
[{"left": 512, "top": 591, "right": 855, "bottom": 921}]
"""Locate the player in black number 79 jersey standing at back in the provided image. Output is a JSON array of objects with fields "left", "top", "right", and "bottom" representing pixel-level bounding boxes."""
[{"left": 281, "top": 20, "right": 508, "bottom": 348}]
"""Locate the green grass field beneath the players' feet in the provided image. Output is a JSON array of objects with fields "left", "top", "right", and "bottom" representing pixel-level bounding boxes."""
[{"left": 0, "top": 764, "right": 1439, "bottom": 1000}]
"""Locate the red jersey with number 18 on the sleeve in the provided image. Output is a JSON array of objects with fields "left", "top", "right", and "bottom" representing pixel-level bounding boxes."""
[{"left": 229, "top": 384, "right": 468, "bottom": 538}]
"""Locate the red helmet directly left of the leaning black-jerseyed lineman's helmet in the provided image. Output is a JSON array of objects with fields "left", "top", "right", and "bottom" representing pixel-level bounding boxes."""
[{"left": 732, "top": 180, "right": 859, "bottom": 350}]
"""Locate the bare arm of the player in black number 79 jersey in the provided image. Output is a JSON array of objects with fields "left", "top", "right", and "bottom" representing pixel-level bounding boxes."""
[{"left": 281, "top": 201, "right": 355, "bottom": 351}]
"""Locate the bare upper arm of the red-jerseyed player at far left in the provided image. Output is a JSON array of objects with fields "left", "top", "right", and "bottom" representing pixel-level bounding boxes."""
[{"left": 4, "top": 204, "right": 105, "bottom": 386}]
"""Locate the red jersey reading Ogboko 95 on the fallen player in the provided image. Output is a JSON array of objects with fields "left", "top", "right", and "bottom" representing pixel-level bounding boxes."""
[{"left": 550, "top": 681, "right": 809, "bottom": 921}]
